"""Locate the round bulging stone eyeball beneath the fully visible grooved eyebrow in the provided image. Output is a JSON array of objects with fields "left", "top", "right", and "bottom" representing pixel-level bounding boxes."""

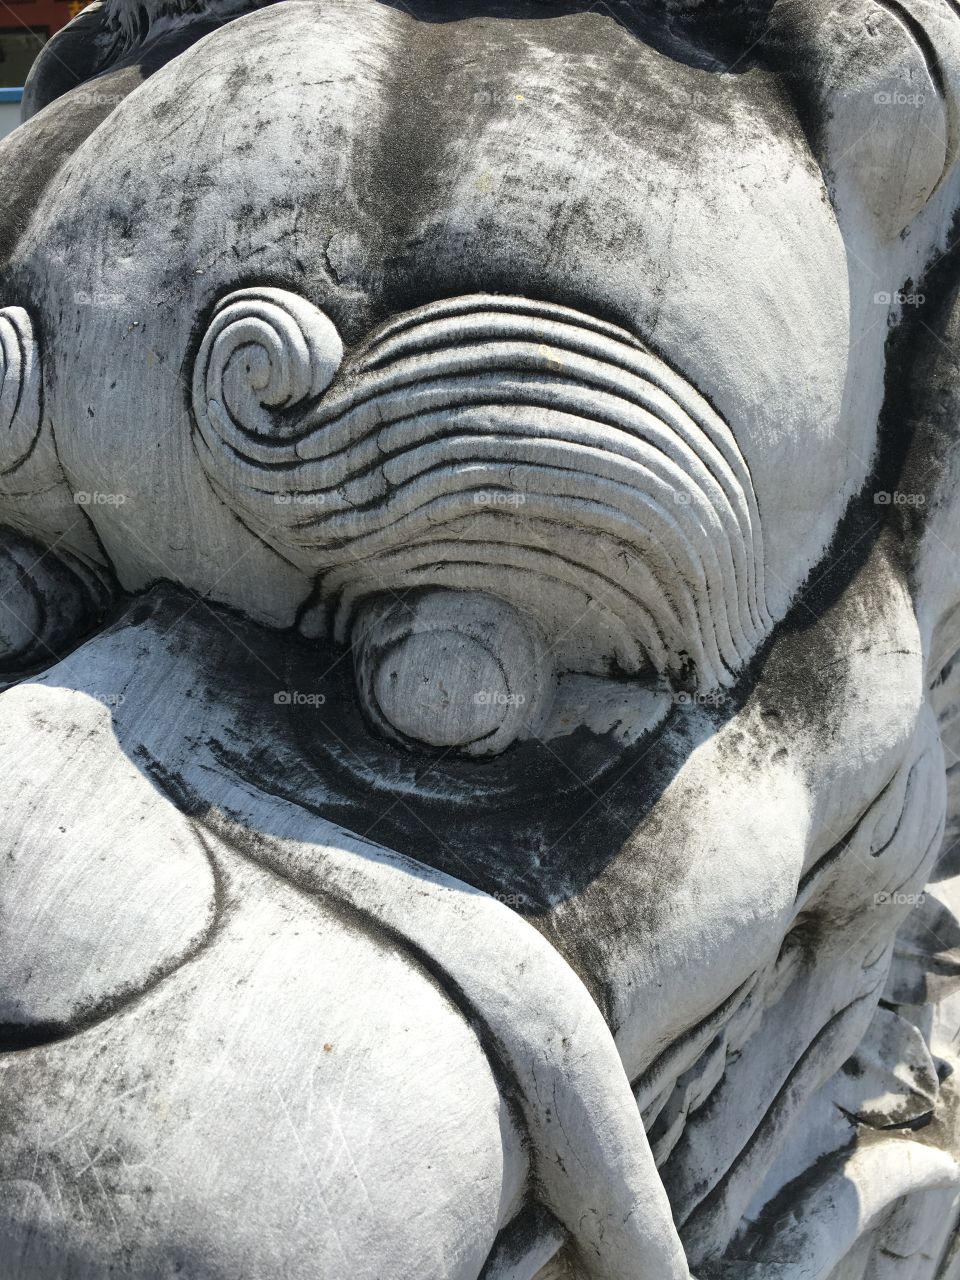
[{"left": 353, "top": 590, "right": 553, "bottom": 755}]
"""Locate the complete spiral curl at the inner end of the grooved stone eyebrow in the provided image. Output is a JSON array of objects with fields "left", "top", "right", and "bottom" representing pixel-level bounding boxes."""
[{"left": 193, "top": 288, "right": 343, "bottom": 448}]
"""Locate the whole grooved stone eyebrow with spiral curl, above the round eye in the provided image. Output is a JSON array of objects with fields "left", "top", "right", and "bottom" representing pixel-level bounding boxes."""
[{"left": 195, "top": 289, "right": 771, "bottom": 687}]
